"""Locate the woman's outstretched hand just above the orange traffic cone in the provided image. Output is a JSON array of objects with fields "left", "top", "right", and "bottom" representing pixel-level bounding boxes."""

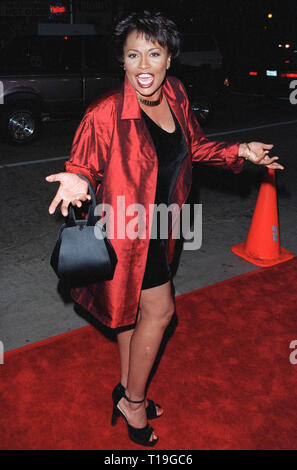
[{"left": 239, "top": 142, "right": 284, "bottom": 170}]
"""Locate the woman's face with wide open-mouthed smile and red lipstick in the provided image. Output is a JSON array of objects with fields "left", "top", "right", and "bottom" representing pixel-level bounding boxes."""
[{"left": 123, "top": 30, "right": 171, "bottom": 100}]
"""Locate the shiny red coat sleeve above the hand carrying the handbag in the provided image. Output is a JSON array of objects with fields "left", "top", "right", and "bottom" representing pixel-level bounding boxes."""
[{"left": 65, "top": 107, "right": 110, "bottom": 189}]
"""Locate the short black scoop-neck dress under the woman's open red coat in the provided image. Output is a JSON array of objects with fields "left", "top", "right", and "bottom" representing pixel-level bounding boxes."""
[{"left": 142, "top": 107, "right": 188, "bottom": 289}]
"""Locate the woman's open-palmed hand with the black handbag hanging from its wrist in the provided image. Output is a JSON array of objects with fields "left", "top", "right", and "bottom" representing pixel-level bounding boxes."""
[{"left": 45, "top": 172, "right": 91, "bottom": 217}]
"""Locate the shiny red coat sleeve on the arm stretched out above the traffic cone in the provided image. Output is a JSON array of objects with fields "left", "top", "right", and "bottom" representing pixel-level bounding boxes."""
[{"left": 179, "top": 83, "right": 244, "bottom": 173}]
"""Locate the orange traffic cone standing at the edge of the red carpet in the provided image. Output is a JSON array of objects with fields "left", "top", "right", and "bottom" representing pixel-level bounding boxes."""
[{"left": 231, "top": 168, "right": 294, "bottom": 266}]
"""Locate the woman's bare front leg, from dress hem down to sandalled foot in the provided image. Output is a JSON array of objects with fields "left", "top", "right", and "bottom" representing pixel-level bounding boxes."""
[{"left": 115, "top": 282, "right": 174, "bottom": 440}]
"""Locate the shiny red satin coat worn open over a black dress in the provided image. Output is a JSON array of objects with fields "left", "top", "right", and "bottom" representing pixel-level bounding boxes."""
[{"left": 65, "top": 77, "right": 244, "bottom": 328}]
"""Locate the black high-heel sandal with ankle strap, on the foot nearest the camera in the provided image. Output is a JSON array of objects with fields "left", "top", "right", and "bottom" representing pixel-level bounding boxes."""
[{"left": 111, "top": 386, "right": 159, "bottom": 447}]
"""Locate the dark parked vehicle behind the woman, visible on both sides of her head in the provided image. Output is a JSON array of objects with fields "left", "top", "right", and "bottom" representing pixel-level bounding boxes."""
[{"left": 0, "top": 29, "right": 226, "bottom": 144}]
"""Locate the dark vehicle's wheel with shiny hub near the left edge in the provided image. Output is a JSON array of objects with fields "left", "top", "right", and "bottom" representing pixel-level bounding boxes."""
[{"left": 4, "top": 108, "right": 41, "bottom": 145}]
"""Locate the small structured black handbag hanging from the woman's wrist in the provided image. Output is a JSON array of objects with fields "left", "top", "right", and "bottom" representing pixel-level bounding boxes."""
[{"left": 50, "top": 175, "right": 117, "bottom": 286}]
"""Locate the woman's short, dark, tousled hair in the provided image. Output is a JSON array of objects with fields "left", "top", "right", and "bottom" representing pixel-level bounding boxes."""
[{"left": 113, "top": 10, "right": 181, "bottom": 62}]
